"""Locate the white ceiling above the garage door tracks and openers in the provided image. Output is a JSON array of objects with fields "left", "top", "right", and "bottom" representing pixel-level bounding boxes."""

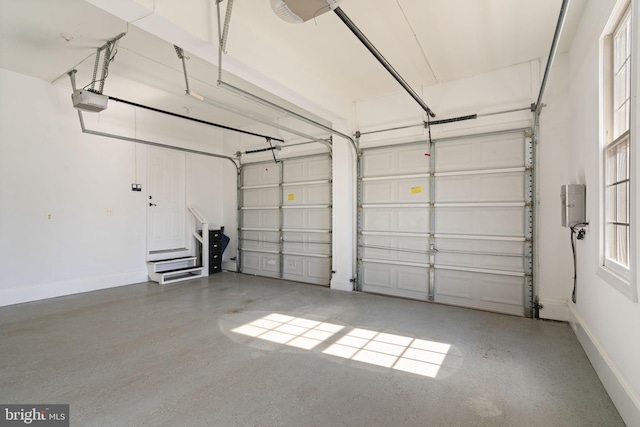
[{"left": 0, "top": 0, "right": 586, "bottom": 139}]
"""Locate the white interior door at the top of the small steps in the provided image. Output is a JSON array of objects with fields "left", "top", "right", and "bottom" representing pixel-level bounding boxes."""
[{"left": 147, "top": 148, "right": 187, "bottom": 254}]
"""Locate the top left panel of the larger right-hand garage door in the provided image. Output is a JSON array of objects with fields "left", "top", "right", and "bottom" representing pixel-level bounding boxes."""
[{"left": 362, "top": 144, "right": 429, "bottom": 177}]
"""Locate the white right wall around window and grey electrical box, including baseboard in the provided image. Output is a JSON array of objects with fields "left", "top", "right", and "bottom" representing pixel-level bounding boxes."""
[{"left": 540, "top": 0, "right": 640, "bottom": 425}]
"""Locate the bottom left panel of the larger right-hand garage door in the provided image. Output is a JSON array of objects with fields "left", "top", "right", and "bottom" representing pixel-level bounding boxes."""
[{"left": 362, "top": 261, "right": 429, "bottom": 300}]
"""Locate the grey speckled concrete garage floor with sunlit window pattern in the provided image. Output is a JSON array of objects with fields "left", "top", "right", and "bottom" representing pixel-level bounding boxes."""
[{"left": 0, "top": 273, "right": 624, "bottom": 427}]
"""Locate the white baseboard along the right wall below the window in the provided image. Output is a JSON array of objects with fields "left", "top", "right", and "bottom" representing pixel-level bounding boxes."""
[{"left": 568, "top": 305, "right": 640, "bottom": 426}]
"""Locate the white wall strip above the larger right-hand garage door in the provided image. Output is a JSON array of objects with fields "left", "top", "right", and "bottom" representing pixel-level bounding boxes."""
[{"left": 355, "top": 61, "right": 539, "bottom": 147}]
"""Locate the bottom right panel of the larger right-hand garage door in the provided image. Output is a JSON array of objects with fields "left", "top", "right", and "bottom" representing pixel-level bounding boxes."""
[{"left": 434, "top": 268, "right": 524, "bottom": 316}]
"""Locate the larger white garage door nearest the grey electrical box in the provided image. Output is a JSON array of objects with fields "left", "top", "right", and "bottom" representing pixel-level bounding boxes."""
[{"left": 359, "top": 130, "right": 533, "bottom": 316}]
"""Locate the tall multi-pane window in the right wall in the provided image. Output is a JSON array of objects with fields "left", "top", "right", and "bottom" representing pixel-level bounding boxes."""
[{"left": 602, "top": 2, "right": 635, "bottom": 299}]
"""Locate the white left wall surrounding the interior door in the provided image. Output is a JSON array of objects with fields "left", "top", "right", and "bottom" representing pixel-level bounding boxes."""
[{"left": 0, "top": 69, "right": 235, "bottom": 305}]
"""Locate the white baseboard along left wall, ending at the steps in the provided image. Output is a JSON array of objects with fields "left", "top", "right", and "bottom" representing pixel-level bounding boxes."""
[{"left": 0, "top": 269, "right": 149, "bottom": 307}]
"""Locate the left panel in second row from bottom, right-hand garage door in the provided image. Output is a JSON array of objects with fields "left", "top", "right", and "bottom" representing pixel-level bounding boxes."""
[{"left": 362, "top": 235, "right": 429, "bottom": 264}]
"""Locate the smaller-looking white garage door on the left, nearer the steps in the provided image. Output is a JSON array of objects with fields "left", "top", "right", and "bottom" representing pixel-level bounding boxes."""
[{"left": 239, "top": 155, "right": 331, "bottom": 286}]
